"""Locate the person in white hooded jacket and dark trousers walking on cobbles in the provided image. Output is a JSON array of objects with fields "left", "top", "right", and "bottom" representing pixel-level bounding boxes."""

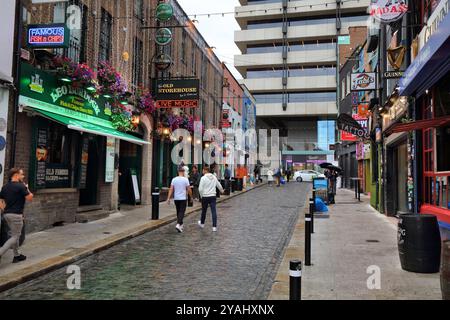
[{"left": 198, "top": 166, "right": 224, "bottom": 232}]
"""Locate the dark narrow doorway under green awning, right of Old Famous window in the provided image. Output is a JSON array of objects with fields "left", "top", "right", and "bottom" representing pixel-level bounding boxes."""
[{"left": 79, "top": 135, "right": 100, "bottom": 206}]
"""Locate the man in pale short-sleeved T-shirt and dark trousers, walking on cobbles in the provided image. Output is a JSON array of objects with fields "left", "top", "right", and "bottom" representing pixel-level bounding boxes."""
[{"left": 167, "top": 166, "right": 192, "bottom": 233}]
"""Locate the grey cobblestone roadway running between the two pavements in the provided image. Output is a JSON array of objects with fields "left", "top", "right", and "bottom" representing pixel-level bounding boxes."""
[{"left": 0, "top": 182, "right": 310, "bottom": 300}]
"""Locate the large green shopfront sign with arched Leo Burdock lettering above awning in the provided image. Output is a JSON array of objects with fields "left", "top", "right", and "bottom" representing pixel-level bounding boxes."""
[{"left": 19, "top": 63, "right": 113, "bottom": 129}]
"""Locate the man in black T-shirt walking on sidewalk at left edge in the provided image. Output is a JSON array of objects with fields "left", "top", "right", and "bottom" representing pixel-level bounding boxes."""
[{"left": 0, "top": 168, "right": 33, "bottom": 263}]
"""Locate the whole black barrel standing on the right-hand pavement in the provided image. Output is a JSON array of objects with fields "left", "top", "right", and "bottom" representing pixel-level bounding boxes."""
[{"left": 397, "top": 214, "right": 441, "bottom": 273}]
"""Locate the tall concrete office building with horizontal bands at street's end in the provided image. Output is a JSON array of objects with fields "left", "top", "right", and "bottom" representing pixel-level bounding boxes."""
[{"left": 235, "top": 0, "right": 370, "bottom": 169}]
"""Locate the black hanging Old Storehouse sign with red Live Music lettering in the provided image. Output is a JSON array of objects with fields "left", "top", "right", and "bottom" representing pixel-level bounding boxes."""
[{"left": 155, "top": 79, "right": 200, "bottom": 108}]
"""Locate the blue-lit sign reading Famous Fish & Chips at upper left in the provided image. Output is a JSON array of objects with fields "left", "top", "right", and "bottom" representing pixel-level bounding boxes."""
[{"left": 27, "top": 23, "right": 70, "bottom": 48}]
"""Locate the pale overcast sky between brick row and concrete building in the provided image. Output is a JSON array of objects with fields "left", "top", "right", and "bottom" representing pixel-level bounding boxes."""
[{"left": 178, "top": 0, "right": 242, "bottom": 78}]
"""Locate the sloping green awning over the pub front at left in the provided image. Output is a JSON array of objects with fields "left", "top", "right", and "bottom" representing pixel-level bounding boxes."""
[{"left": 33, "top": 109, "right": 150, "bottom": 145}]
